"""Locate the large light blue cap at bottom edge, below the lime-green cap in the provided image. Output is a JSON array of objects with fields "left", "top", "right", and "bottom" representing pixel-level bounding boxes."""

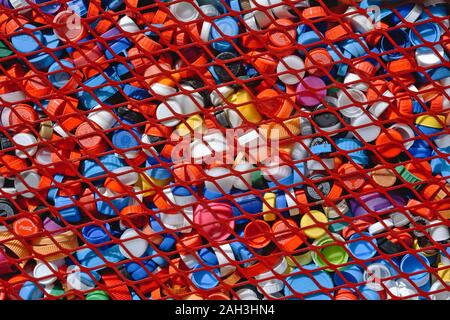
[{"left": 284, "top": 264, "right": 334, "bottom": 300}]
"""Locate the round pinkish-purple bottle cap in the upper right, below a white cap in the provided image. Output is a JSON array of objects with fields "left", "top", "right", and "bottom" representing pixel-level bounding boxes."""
[{"left": 297, "top": 76, "right": 327, "bottom": 107}]
